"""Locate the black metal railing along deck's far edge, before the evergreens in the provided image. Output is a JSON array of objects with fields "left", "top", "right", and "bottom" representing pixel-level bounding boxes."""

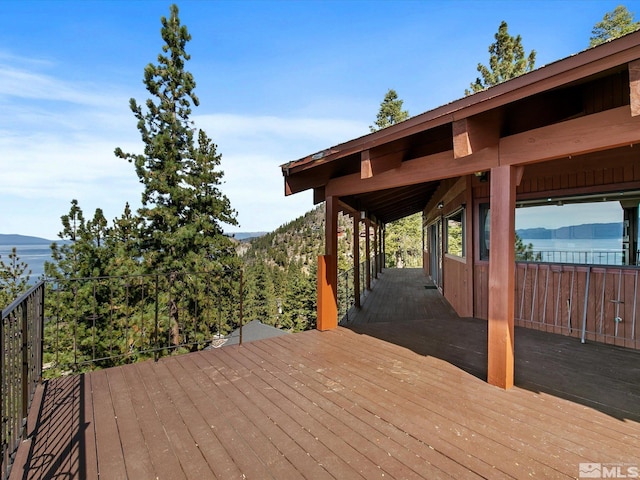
[{"left": 44, "top": 270, "right": 243, "bottom": 377}]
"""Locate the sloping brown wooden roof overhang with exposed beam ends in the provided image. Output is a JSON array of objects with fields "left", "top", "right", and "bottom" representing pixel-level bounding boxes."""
[{"left": 281, "top": 31, "right": 640, "bottom": 223}]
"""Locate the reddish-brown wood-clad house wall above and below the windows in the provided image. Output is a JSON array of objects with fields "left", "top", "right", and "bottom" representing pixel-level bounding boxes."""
[{"left": 424, "top": 147, "right": 640, "bottom": 349}]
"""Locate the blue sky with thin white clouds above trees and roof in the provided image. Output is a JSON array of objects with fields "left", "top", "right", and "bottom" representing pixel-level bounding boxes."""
[{"left": 0, "top": 0, "right": 640, "bottom": 239}]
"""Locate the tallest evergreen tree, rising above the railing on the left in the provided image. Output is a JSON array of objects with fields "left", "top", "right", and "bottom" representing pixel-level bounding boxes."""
[{"left": 115, "top": 5, "right": 237, "bottom": 272}]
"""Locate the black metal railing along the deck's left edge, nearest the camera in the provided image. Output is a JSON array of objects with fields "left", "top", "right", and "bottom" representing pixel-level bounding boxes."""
[{"left": 0, "top": 282, "right": 45, "bottom": 480}]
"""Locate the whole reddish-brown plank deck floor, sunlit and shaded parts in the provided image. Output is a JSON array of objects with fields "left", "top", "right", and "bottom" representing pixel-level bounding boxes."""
[{"left": 11, "top": 270, "right": 640, "bottom": 480}]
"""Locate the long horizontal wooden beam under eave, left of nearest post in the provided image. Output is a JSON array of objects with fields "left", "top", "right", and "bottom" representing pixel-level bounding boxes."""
[{"left": 326, "top": 148, "right": 498, "bottom": 196}]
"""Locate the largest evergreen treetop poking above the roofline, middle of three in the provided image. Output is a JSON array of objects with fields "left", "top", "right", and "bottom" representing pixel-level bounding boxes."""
[{"left": 465, "top": 20, "right": 536, "bottom": 95}]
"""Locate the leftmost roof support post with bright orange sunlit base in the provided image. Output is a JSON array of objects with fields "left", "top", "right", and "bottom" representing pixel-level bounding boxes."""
[{"left": 316, "top": 197, "right": 338, "bottom": 330}]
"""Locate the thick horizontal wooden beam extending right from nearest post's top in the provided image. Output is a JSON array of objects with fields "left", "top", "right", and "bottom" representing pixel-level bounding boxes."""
[{"left": 500, "top": 105, "right": 640, "bottom": 165}]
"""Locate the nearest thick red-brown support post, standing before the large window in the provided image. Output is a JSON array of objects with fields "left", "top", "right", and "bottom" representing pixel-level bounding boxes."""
[{"left": 487, "top": 165, "right": 517, "bottom": 389}]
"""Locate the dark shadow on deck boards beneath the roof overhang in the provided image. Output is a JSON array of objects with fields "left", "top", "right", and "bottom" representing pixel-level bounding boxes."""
[{"left": 343, "top": 269, "right": 640, "bottom": 421}]
